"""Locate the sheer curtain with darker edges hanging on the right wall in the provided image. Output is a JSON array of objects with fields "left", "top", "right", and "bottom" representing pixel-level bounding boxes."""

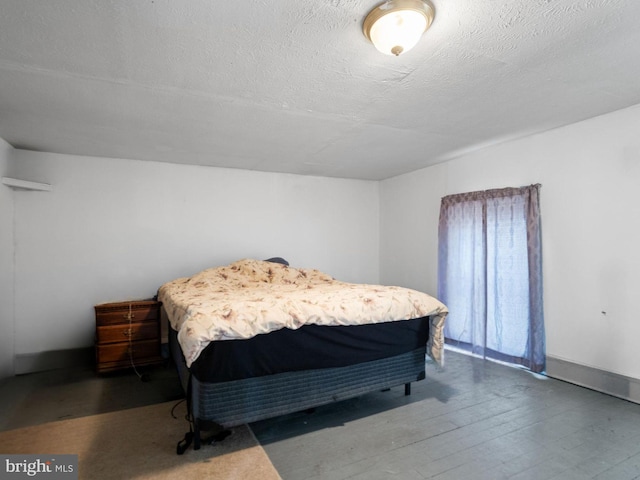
[{"left": 438, "top": 185, "right": 545, "bottom": 372}]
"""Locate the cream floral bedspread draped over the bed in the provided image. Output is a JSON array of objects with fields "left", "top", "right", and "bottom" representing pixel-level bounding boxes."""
[{"left": 158, "top": 259, "right": 448, "bottom": 366}]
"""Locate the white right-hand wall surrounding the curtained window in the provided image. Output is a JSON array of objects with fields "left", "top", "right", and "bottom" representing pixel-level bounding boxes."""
[{"left": 380, "top": 106, "right": 640, "bottom": 379}]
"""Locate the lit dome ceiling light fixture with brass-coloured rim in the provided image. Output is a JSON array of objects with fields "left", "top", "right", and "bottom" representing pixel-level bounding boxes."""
[{"left": 362, "top": 0, "right": 435, "bottom": 56}]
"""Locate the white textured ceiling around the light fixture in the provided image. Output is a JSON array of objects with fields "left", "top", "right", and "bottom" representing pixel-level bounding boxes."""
[{"left": 0, "top": 0, "right": 640, "bottom": 179}]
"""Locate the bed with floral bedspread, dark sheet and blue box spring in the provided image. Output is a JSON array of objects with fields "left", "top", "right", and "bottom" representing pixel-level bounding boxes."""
[{"left": 158, "top": 257, "right": 447, "bottom": 453}]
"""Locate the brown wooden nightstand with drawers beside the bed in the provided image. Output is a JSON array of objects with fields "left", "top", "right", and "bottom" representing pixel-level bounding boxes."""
[{"left": 95, "top": 300, "right": 163, "bottom": 373}]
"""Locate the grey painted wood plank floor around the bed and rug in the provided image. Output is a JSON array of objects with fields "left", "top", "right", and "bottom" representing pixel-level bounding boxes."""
[{"left": 0, "top": 351, "right": 640, "bottom": 480}]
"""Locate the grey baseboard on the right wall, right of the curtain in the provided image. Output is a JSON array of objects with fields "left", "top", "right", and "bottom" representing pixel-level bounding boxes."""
[{"left": 546, "top": 355, "right": 640, "bottom": 403}]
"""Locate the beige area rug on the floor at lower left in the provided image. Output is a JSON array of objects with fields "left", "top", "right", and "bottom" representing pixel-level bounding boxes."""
[{"left": 0, "top": 402, "right": 280, "bottom": 480}]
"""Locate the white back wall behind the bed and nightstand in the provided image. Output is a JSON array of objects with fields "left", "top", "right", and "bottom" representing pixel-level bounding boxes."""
[{"left": 11, "top": 150, "right": 379, "bottom": 372}]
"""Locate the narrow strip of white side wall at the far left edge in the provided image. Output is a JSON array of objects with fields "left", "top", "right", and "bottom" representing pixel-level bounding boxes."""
[{"left": 0, "top": 138, "right": 14, "bottom": 378}]
